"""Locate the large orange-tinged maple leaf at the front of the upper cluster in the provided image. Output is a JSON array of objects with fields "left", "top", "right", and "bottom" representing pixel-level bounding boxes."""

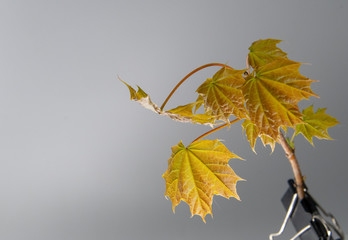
[{"left": 242, "top": 58, "right": 317, "bottom": 140}]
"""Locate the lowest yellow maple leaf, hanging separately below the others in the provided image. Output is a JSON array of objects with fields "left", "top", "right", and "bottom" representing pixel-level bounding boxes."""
[{"left": 163, "top": 140, "right": 243, "bottom": 222}]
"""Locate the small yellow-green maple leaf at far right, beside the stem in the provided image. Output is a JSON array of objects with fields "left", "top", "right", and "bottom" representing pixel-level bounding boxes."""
[{"left": 292, "top": 106, "right": 339, "bottom": 145}]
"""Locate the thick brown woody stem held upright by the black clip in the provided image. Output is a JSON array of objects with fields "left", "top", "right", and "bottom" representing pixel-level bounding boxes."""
[{"left": 279, "top": 131, "right": 305, "bottom": 199}]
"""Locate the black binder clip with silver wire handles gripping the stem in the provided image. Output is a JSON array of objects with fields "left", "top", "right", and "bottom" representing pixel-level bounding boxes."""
[{"left": 269, "top": 179, "right": 344, "bottom": 240}]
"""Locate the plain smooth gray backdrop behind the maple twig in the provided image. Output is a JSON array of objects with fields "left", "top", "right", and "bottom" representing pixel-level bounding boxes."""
[{"left": 0, "top": 0, "right": 348, "bottom": 240}]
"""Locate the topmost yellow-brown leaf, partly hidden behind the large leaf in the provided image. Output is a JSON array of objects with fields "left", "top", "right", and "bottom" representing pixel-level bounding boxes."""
[{"left": 248, "top": 39, "right": 287, "bottom": 69}]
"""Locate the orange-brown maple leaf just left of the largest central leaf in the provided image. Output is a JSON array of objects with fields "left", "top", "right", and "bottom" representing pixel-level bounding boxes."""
[{"left": 197, "top": 67, "right": 247, "bottom": 122}]
